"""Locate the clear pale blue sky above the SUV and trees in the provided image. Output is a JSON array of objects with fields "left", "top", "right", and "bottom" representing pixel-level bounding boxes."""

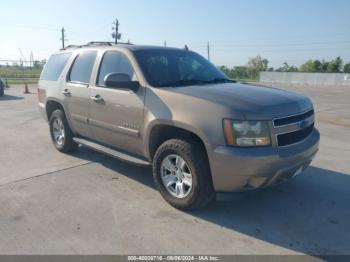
[{"left": 0, "top": 0, "right": 350, "bottom": 68}]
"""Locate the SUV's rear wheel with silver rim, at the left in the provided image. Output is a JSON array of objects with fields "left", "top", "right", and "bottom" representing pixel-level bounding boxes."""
[{"left": 49, "top": 109, "right": 78, "bottom": 153}]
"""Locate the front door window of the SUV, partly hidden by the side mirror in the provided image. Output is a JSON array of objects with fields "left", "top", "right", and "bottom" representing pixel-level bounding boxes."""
[{"left": 97, "top": 52, "right": 134, "bottom": 86}]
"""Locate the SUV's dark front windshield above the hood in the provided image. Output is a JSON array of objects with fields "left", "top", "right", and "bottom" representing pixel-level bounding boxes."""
[{"left": 134, "top": 49, "right": 231, "bottom": 87}]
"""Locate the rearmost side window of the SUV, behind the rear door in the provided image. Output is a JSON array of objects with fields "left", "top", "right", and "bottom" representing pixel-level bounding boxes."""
[{"left": 40, "top": 53, "right": 71, "bottom": 81}]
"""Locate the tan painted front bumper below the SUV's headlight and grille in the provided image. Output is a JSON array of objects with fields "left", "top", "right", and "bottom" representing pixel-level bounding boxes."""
[{"left": 208, "top": 128, "right": 320, "bottom": 192}]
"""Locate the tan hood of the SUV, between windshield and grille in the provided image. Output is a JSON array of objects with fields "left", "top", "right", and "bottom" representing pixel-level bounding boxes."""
[{"left": 167, "top": 83, "right": 312, "bottom": 120}]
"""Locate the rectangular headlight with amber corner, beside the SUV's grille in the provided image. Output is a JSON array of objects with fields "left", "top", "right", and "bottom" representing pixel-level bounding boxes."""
[{"left": 224, "top": 119, "right": 271, "bottom": 147}]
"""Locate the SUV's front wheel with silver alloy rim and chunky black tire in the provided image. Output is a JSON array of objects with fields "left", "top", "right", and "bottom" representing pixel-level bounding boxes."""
[{"left": 153, "top": 139, "right": 215, "bottom": 210}]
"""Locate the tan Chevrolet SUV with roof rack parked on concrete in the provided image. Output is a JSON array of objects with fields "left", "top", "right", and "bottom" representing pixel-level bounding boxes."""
[{"left": 38, "top": 42, "right": 320, "bottom": 209}]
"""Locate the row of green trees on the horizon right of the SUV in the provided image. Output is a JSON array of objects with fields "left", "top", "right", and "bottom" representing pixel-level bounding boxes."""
[{"left": 219, "top": 56, "right": 350, "bottom": 80}]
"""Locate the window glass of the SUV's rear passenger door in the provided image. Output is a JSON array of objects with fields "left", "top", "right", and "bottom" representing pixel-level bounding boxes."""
[{"left": 69, "top": 51, "right": 96, "bottom": 84}]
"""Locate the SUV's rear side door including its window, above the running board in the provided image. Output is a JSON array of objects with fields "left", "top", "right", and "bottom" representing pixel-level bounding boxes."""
[{"left": 61, "top": 51, "right": 97, "bottom": 138}]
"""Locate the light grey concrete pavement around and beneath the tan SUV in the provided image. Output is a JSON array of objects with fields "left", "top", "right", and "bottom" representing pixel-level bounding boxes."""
[{"left": 0, "top": 86, "right": 350, "bottom": 255}]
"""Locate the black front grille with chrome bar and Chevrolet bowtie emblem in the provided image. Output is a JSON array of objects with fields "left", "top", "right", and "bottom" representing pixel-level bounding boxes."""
[{"left": 273, "top": 110, "right": 315, "bottom": 146}]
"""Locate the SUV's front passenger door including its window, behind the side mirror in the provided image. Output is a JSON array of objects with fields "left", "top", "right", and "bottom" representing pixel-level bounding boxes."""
[{"left": 89, "top": 51, "right": 144, "bottom": 154}]
